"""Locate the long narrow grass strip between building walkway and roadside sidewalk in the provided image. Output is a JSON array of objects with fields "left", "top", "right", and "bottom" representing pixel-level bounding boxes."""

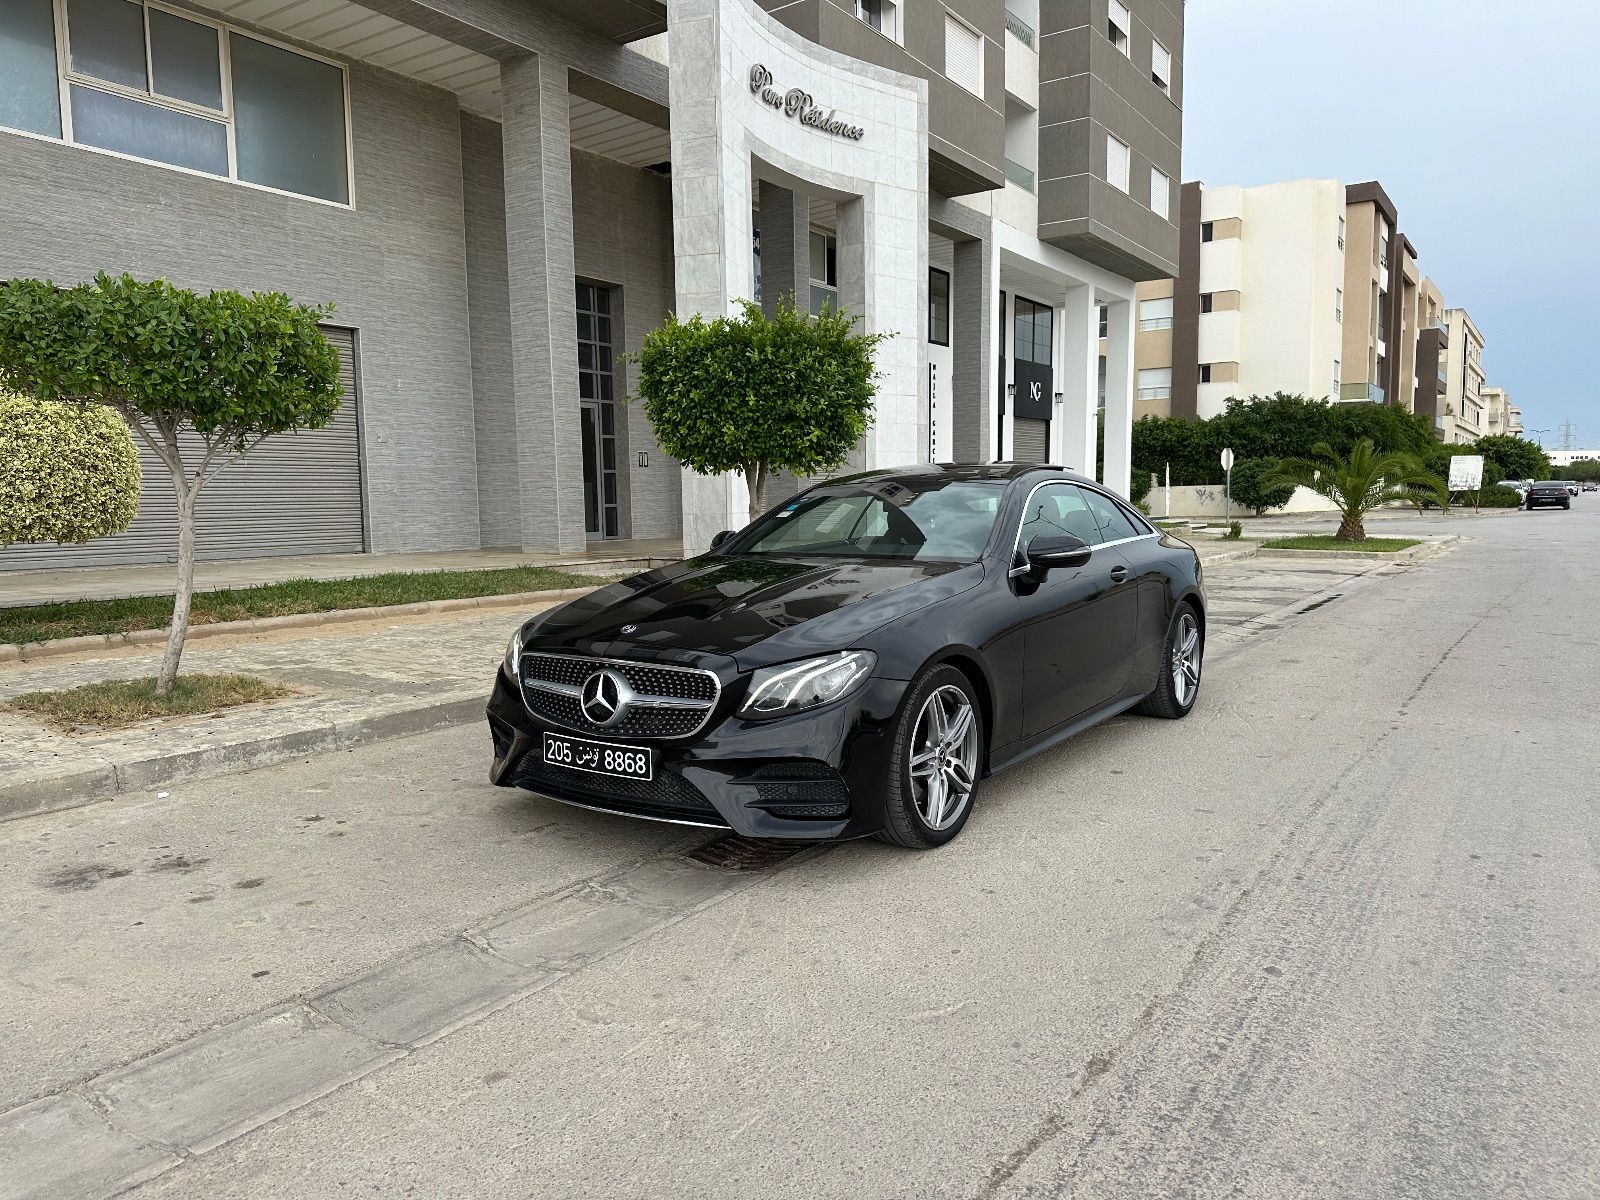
[{"left": 0, "top": 566, "right": 606, "bottom": 645}]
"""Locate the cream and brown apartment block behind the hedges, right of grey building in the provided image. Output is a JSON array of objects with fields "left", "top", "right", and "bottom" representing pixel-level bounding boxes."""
[{"left": 1136, "top": 179, "right": 1424, "bottom": 418}]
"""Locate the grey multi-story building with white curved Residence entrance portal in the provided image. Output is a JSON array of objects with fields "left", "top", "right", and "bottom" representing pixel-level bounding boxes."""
[{"left": 0, "top": 0, "right": 1184, "bottom": 570}]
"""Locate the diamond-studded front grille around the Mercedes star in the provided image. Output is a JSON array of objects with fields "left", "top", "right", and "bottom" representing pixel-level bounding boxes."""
[{"left": 518, "top": 654, "right": 722, "bottom": 739}]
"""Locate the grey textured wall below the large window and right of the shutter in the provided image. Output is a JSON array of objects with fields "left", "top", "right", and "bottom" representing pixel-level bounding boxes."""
[{"left": 0, "top": 66, "right": 478, "bottom": 552}]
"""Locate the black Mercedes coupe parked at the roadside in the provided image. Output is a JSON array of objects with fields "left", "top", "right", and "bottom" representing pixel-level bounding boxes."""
[{"left": 488, "top": 462, "right": 1205, "bottom": 850}]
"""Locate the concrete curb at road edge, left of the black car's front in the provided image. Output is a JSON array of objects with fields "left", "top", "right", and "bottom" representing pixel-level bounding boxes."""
[{"left": 0, "top": 696, "right": 488, "bottom": 822}]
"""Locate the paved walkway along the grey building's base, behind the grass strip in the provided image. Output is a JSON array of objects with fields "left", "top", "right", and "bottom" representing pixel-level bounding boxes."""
[{"left": 0, "top": 538, "right": 683, "bottom": 605}]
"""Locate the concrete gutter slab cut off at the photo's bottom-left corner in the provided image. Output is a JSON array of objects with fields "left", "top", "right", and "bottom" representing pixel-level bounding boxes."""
[{"left": 0, "top": 1093, "right": 182, "bottom": 1200}]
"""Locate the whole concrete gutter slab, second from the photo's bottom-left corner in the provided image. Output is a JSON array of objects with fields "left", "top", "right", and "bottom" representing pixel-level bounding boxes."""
[{"left": 90, "top": 1005, "right": 402, "bottom": 1154}]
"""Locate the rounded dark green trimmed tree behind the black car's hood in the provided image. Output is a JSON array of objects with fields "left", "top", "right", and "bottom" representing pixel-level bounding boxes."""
[{"left": 635, "top": 296, "right": 890, "bottom": 517}]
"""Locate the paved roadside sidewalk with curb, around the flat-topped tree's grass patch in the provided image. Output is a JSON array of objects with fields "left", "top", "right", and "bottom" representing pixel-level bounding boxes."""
[{"left": 0, "top": 542, "right": 1256, "bottom": 821}]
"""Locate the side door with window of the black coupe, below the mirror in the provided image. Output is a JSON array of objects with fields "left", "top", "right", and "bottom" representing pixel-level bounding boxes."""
[{"left": 1011, "top": 482, "right": 1138, "bottom": 738}]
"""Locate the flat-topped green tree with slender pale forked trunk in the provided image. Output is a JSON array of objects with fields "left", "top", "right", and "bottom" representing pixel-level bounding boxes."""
[{"left": 0, "top": 274, "right": 342, "bottom": 696}]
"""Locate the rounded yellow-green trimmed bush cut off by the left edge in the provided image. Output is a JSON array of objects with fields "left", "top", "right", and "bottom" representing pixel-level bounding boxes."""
[{"left": 0, "top": 392, "right": 139, "bottom": 546}]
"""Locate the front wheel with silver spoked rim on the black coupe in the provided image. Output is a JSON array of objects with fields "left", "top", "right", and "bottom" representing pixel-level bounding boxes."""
[{"left": 878, "top": 666, "right": 984, "bottom": 850}]
